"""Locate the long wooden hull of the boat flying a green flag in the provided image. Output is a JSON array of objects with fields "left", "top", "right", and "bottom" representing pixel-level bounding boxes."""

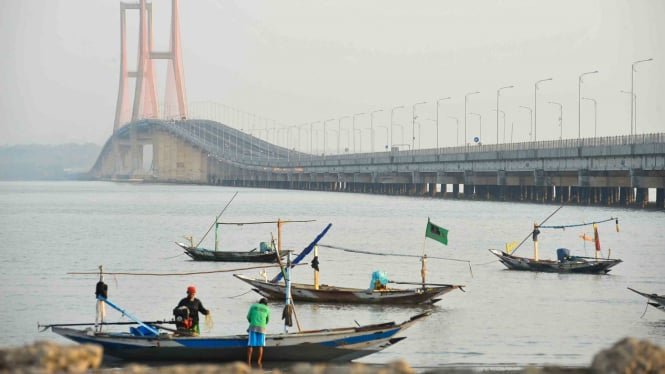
[{"left": 234, "top": 274, "right": 462, "bottom": 305}]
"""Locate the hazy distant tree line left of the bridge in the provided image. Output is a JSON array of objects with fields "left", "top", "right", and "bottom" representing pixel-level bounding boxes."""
[{"left": 0, "top": 143, "right": 101, "bottom": 180}]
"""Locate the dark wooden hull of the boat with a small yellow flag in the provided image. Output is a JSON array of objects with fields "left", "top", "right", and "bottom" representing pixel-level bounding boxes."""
[{"left": 489, "top": 249, "right": 622, "bottom": 274}]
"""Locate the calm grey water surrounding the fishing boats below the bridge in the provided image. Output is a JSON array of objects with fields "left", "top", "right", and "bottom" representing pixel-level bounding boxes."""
[{"left": 0, "top": 182, "right": 665, "bottom": 368}]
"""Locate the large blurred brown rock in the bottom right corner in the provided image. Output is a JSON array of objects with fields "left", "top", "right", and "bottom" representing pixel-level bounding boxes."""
[{"left": 591, "top": 338, "right": 665, "bottom": 374}]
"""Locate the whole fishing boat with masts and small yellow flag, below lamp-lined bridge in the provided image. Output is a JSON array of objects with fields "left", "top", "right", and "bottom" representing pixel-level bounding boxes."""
[{"left": 489, "top": 212, "right": 622, "bottom": 274}]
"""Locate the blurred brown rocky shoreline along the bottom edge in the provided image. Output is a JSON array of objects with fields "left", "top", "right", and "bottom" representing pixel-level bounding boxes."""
[{"left": 0, "top": 338, "right": 665, "bottom": 374}]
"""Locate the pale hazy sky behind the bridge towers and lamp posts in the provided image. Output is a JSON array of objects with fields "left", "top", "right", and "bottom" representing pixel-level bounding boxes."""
[{"left": 0, "top": 0, "right": 665, "bottom": 147}]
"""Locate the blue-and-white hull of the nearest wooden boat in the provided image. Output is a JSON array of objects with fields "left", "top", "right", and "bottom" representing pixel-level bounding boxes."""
[{"left": 50, "top": 312, "right": 431, "bottom": 362}]
